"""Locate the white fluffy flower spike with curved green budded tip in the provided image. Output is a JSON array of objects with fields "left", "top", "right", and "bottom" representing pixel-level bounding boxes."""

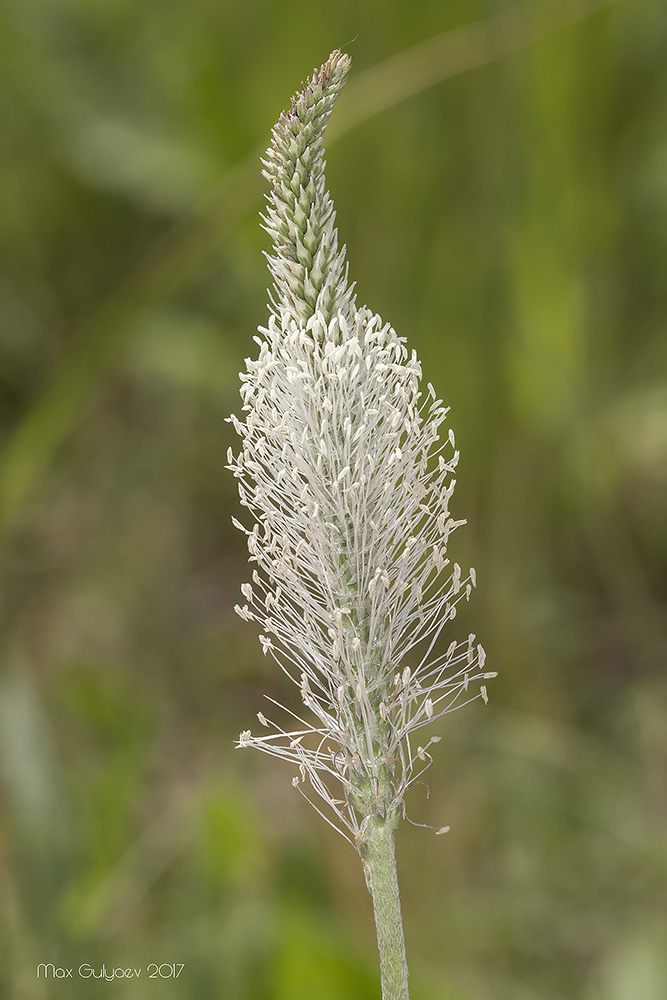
[{"left": 229, "top": 52, "right": 495, "bottom": 846}]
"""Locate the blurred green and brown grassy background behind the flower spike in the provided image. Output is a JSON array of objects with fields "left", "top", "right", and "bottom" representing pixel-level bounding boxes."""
[{"left": 0, "top": 0, "right": 667, "bottom": 1000}]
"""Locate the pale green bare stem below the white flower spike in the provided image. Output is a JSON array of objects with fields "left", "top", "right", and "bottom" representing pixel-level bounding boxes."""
[{"left": 361, "top": 817, "right": 409, "bottom": 1000}]
